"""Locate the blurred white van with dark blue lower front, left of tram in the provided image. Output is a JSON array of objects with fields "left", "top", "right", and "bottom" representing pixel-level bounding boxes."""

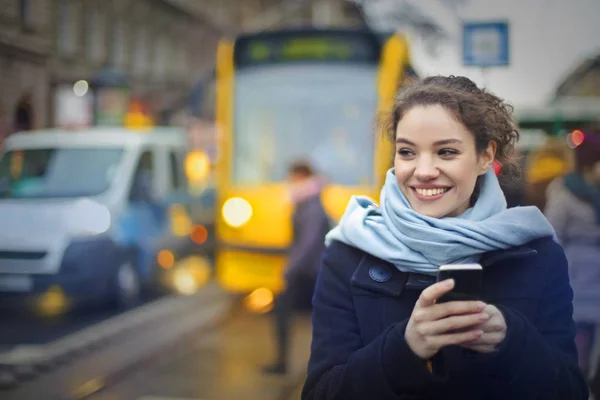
[{"left": 0, "top": 128, "right": 186, "bottom": 306}]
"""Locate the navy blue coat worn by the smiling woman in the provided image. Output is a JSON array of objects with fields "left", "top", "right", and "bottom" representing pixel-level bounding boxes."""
[{"left": 302, "top": 238, "right": 588, "bottom": 400}]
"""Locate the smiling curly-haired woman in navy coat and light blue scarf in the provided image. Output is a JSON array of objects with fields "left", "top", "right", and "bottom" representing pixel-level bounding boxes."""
[{"left": 302, "top": 76, "right": 588, "bottom": 400}]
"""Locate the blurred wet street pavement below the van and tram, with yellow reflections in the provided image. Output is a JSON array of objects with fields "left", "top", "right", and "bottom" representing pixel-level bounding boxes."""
[{"left": 0, "top": 283, "right": 311, "bottom": 400}]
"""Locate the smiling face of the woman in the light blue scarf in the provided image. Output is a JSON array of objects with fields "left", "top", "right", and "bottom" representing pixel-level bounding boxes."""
[{"left": 394, "top": 105, "right": 496, "bottom": 218}]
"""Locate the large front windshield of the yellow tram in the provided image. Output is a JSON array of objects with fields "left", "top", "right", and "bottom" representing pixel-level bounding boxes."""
[{"left": 232, "top": 65, "right": 377, "bottom": 185}]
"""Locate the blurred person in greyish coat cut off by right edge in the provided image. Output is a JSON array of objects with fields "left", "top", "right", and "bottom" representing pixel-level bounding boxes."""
[{"left": 545, "top": 131, "right": 600, "bottom": 394}]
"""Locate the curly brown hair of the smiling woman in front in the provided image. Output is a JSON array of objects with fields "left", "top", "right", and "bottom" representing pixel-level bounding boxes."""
[{"left": 379, "top": 75, "right": 519, "bottom": 178}]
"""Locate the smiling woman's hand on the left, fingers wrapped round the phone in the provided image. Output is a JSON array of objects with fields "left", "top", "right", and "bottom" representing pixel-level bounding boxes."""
[{"left": 404, "top": 279, "right": 490, "bottom": 360}]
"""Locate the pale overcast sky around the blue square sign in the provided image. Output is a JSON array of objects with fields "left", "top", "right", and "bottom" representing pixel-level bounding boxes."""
[{"left": 366, "top": 0, "right": 600, "bottom": 106}]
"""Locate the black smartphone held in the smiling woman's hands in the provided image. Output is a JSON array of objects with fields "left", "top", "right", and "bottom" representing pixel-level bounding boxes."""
[{"left": 437, "top": 264, "right": 483, "bottom": 303}]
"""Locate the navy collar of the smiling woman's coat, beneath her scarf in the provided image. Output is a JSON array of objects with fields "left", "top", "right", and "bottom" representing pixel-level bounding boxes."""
[{"left": 352, "top": 246, "right": 537, "bottom": 297}]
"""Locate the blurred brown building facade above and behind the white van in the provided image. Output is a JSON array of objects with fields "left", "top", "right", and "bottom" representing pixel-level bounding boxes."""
[{"left": 0, "top": 0, "right": 222, "bottom": 137}]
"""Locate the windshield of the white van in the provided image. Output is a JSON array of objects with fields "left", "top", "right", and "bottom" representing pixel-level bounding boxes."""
[{"left": 0, "top": 147, "right": 124, "bottom": 199}]
